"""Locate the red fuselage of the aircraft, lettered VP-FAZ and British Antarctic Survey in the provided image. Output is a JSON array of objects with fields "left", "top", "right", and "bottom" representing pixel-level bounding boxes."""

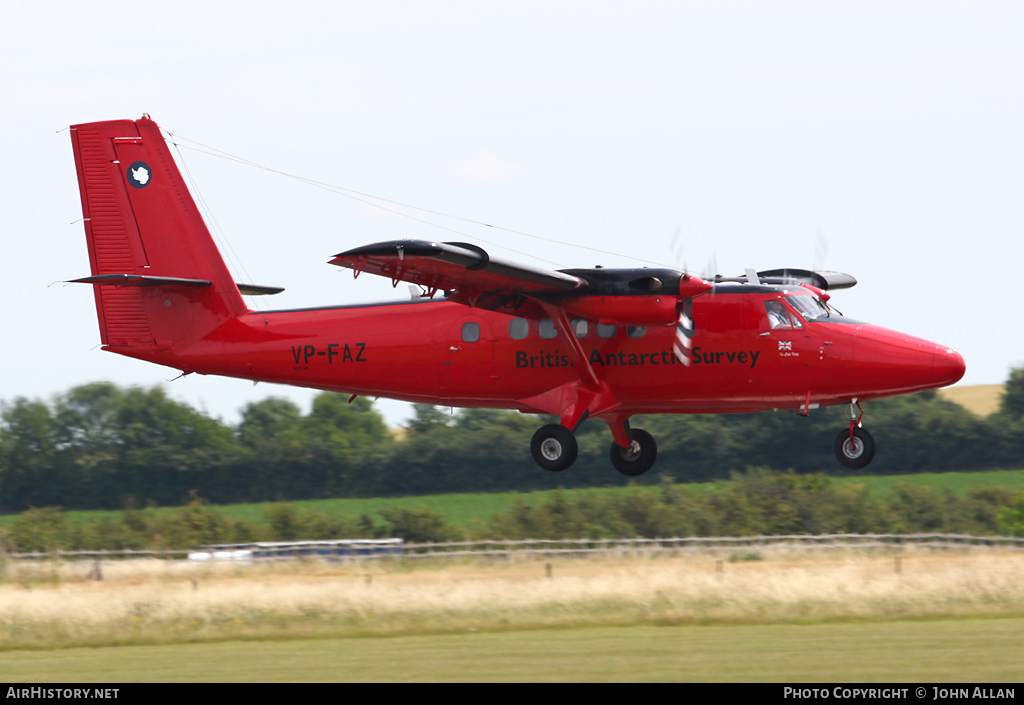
[{"left": 117, "top": 285, "right": 965, "bottom": 413}]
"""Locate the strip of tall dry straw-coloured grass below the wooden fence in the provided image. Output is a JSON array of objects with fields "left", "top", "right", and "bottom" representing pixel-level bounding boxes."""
[{"left": 0, "top": 551, "right": 1024, "bottom": 649}]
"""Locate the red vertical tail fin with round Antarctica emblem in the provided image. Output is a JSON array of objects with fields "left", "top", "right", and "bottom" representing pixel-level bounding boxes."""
[{"left": 71, "top": 118, "right": 247, "bottom": 353}]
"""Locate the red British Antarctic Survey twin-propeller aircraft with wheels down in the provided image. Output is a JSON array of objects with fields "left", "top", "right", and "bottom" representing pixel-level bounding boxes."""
[{"left": 71, "top": 117, "right": 965, "bottom": 475}]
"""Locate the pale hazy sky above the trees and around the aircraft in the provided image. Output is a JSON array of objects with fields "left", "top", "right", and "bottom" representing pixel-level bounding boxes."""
[{"left": 0, "top": 0, "right": 1024, "bottom": 426}]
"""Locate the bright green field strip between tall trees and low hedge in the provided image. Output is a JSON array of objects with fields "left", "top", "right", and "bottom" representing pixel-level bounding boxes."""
[{"left": 0, "top": 469, "right": 1024, "bottom": 529}]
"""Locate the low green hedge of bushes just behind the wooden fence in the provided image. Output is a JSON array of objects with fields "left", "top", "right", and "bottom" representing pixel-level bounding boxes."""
[{"left": 8, "top": 468, "right": 1024, "bottom": 551}]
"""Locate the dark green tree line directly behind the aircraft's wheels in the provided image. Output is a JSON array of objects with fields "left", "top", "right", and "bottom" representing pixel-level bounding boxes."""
[{"left": 0, "top": 369, "right": 1024, "bottom": 512}]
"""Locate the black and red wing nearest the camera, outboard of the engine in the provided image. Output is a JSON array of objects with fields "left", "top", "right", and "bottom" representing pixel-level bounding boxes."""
[{"left": 331, "top": 240, "right": 587, "bottom": 308}]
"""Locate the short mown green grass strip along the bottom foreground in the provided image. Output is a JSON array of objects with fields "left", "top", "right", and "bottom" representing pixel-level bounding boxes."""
[{"left": 0, "top": 619, "right": 1024, "bottom": 684}]
